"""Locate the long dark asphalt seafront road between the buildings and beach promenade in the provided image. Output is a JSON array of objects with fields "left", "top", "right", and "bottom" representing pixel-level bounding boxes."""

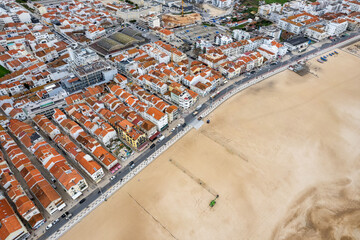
[{"left": 39, "top": 30, "right": 358, "bottom": 240}]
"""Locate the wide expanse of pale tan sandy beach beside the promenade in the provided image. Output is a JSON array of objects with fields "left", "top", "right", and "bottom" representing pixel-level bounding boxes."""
[{"left": 62, "top": 50, "right": 360, "bottom": 240}]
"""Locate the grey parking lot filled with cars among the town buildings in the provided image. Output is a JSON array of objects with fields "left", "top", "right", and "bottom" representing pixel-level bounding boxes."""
[{"left": 175, "top": 25, "right": 225, "bottom": 44}]
